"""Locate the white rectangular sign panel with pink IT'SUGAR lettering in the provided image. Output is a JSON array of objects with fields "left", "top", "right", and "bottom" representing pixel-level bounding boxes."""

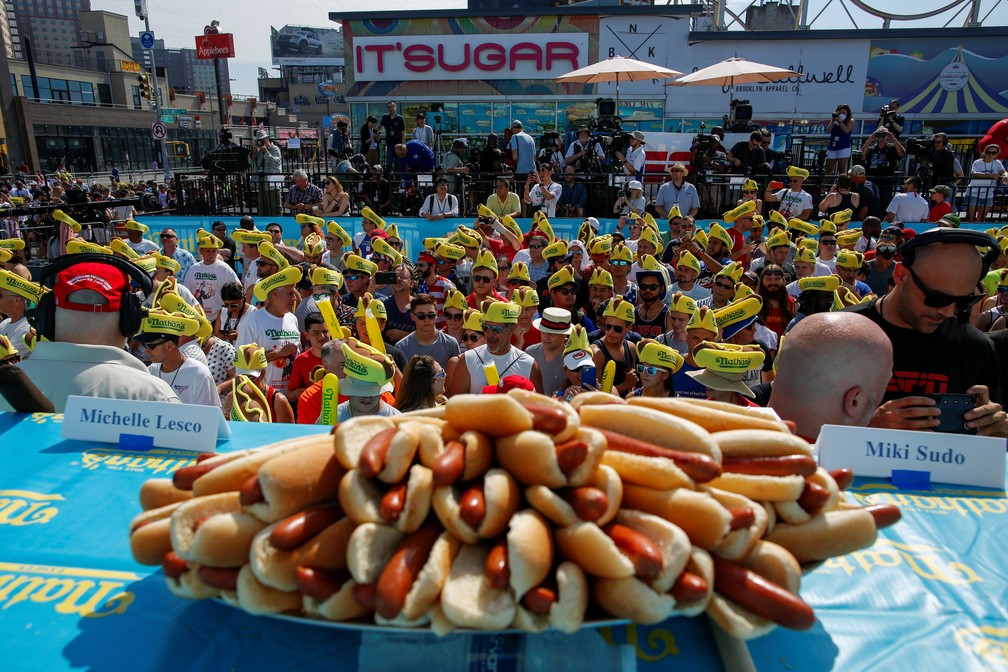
[{"left": 353, "top": 32, "right": 588, "bottom": 82}]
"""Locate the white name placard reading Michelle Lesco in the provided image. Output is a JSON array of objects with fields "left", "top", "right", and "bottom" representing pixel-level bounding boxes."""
[{"left": 62, "top": 396, "right": 231, "bottom": 452}]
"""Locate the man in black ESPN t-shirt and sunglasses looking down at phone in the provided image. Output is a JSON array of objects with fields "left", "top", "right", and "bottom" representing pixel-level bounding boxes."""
[{"left": 847, "top": 234, "right": 1008, "bottom": 436}]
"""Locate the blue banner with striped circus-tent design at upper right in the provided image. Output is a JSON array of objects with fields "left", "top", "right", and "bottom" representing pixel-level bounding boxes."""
[{"left": 864, "top": 37, "right": 1008, "bottom": 116}]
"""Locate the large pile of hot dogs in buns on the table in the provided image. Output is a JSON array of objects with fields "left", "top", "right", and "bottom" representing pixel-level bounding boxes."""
[{"left": 130, "top": 390, "right": 899, "bottom": 639}]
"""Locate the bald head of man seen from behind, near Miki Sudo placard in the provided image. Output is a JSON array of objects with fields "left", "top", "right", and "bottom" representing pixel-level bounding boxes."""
[{"left": 770, "top": 312, "right": 892, "bottom": 442}]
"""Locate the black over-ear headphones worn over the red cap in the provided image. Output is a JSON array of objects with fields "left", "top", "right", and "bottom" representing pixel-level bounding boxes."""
[{"left": 28, "top": 254, "right": 154, "bottom": 341}]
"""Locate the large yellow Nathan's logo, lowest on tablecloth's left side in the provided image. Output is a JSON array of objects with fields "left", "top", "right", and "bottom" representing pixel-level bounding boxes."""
[{"left": 0, "top": 562, "right": 141, "bottom": 619}]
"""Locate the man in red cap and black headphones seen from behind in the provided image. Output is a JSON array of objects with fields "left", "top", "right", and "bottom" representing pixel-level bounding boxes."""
[{"left": 0, "top": 255, "right": 178, "bottom": 413}]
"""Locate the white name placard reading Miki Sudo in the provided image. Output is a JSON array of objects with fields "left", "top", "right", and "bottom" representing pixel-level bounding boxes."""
[{"left": 815, "top": 425, "right": 1005, "bottom": 489}]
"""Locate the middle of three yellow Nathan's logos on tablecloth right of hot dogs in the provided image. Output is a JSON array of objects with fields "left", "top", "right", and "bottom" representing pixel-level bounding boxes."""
[{"left": 823, "top": 539, "right": 984, "bottom": 585}]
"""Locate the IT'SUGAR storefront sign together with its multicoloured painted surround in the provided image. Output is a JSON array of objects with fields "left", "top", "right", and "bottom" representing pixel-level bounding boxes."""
[{"left": 343, "top": 15, "right": 599, "bottom": 100}]
